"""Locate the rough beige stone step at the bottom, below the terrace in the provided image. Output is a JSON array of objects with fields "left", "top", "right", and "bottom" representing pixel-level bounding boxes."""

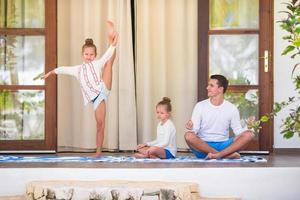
[{"left": 26, "top": 180, "right": 200, "bottom": 200}]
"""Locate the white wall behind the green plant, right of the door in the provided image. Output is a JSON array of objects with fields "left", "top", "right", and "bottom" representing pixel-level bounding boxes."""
[{"left": 274, "top": 0, "right": 300, "bottom": 148}]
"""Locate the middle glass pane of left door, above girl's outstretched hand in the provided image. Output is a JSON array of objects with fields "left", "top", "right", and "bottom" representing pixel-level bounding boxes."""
[{"left": 0, "top": 36, "right": 45, "bottom": 85}]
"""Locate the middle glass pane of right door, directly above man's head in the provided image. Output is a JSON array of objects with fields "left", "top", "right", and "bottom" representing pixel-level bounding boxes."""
[{"left": 209, "top": 35, "right": 259, "bottom": 85}]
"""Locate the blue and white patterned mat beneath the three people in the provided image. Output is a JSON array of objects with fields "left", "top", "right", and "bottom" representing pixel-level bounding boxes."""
[{"left": 0, "top": 155, "right": 267, "bottom": 163}]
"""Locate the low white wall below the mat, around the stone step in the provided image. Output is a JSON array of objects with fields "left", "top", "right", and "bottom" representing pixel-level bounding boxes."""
[{"left": 0, "top": 167, "right": 300, "bottom": 200}]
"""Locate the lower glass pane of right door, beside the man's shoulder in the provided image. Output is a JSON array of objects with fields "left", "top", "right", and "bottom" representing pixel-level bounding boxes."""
[{"left": 225, "top": 89, "right": 259, "bottom": 137}]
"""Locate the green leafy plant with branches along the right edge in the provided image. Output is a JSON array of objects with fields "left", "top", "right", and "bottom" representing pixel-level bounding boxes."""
[{"left": 250, "top": 0, "right": 300, "bottom": 139}]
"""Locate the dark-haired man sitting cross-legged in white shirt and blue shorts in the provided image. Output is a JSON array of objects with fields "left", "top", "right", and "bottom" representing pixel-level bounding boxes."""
[{"left": 185, "top": 75, "right": 254, "bottom": 159}]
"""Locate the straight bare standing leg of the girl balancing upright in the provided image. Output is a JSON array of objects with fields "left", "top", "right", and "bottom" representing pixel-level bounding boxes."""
[{"left": 93, "top": 100, "right": 106, "bottom": 157}]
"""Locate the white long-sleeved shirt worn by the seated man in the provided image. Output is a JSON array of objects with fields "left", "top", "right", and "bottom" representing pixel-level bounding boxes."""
[{"left": 191, "top": 99, "right": 248, "bottom": 142}]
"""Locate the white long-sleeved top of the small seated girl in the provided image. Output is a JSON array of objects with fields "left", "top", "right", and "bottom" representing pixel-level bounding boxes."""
[{"left": 146, "top": 119, "right": 177, "bottom": 157}]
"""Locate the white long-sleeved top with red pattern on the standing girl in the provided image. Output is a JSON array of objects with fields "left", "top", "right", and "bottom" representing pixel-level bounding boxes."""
[{"left": 54, "top": 45, "right": 115, "bottom": 105}]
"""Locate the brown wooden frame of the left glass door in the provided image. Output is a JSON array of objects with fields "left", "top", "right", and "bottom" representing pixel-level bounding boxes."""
[{"left": 0, "top": 0, "right": 57, "bottom": 151}]
